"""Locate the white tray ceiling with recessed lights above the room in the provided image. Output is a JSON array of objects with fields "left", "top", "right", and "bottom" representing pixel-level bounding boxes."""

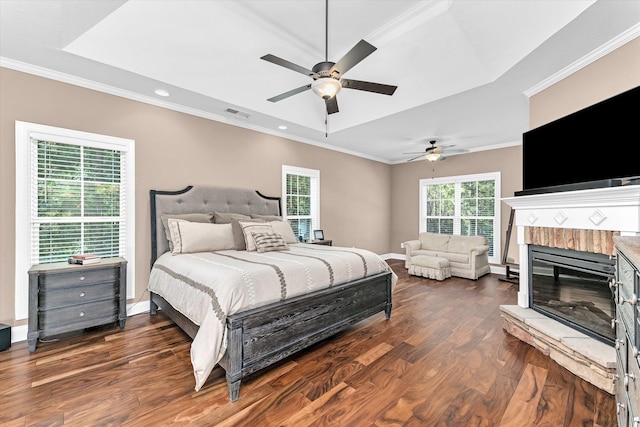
[{"left": 0, "top": 0, "right": 640, "bottom": 163}]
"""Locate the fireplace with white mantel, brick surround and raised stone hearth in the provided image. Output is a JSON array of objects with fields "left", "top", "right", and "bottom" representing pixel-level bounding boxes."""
[{"left": 500, "top": 183, "right": 640, "bottom": 393}]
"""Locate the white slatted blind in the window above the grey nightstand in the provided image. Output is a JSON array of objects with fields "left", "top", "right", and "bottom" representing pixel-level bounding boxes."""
[{"left": 31, "top": 138, "right": 127, "bottom": 264}]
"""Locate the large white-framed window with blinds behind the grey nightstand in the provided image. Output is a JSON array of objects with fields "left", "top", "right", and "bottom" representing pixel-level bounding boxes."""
[{"left": 16, "top": 122, "right": 135, "bottom": 318}]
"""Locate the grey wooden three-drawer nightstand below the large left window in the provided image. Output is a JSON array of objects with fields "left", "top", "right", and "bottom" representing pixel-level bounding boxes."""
[{"left": 27, "top": 258, "right": 127, "bottom": 352}]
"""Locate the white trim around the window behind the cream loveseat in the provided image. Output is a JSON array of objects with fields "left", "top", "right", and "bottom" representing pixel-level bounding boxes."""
[{"left": 418, "top": 172, "right": 502, "bottom": 264}]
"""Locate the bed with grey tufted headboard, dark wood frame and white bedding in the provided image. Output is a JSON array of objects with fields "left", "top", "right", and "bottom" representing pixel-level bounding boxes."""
[{"left": 148, "top": 186, "right": 397, "bottom": 402}]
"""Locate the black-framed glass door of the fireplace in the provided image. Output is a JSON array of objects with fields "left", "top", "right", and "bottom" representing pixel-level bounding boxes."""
[{"left": 529, "top": 245, "right": 615, "bottom": 344}]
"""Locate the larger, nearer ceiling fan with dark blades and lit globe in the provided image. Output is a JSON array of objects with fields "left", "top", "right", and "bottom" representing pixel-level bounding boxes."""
[{"left": 260, "top": 0, "right": 397, "bottom": 114}]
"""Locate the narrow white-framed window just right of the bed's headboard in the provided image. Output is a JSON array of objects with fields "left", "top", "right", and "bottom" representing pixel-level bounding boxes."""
[{"left": 282, "top": 165, "right": 320, "bottom": 241}]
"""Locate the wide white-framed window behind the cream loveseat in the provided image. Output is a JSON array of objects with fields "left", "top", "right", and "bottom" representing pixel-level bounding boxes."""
[{"left": 420, "top": 172, "right": 500, "bottom": 264}]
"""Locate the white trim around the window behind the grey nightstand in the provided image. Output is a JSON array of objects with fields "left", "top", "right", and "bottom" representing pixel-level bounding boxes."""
[{"left": 14, "top": 120, "right": 136, "bottom": 320}]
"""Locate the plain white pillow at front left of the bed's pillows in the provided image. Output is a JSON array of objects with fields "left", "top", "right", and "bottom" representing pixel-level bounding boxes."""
[{"left": 168, "top": 218, "right": 234, "bottom": 255}]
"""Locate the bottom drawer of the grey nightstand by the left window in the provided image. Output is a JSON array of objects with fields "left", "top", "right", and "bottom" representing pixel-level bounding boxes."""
[{"left": 38, "top": 299, "right": 118, "bottom": 330}]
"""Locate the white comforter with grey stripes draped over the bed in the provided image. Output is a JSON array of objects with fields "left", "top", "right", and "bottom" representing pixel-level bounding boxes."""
[{"left": 149, "top": 243, "right": 397, "bottom": 391}]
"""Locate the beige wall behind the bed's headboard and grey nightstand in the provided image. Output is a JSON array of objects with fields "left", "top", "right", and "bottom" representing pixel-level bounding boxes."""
[{"left": 0, "top": 68, "right": 391, "bottom": 326}]
